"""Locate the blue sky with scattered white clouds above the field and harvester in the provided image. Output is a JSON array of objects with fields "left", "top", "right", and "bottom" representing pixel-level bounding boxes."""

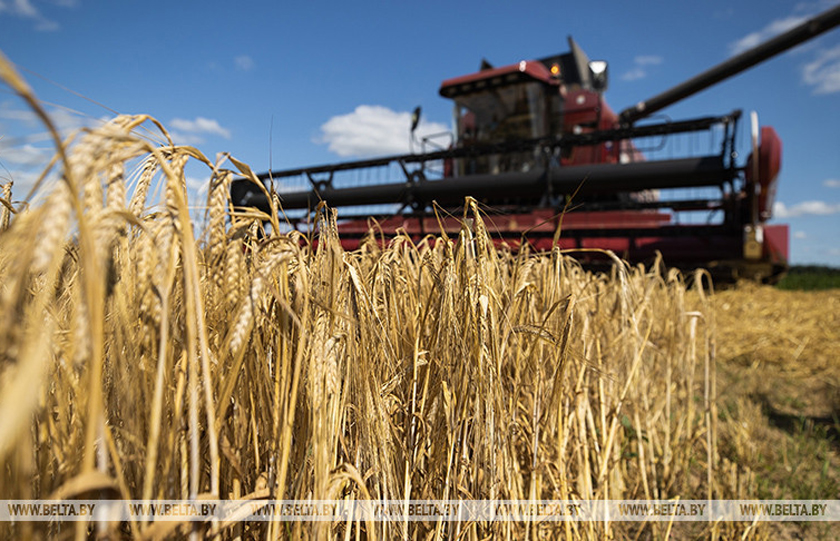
[{"left": 0, "top": 0, "right": 840, "bottom": 266}]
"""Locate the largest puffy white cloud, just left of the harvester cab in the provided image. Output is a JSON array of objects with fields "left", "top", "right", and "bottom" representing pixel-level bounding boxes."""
[{"left": 316, "top": 105, "right": 449, "bottom": 157}]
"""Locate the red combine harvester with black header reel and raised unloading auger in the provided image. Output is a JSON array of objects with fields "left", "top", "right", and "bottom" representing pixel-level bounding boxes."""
[{"left": 231, "top": 6, "right": 840, "bottom": 279}]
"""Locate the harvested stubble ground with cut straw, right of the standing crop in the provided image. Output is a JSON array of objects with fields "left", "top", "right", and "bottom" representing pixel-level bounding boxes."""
[{"left": 713, "top": 283, "right": 840, "bottom": 539}]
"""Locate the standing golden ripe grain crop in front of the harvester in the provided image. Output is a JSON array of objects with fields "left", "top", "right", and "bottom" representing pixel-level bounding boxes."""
[{"left": 0, "top": 51, "right": 780, "bottom": 540}]
